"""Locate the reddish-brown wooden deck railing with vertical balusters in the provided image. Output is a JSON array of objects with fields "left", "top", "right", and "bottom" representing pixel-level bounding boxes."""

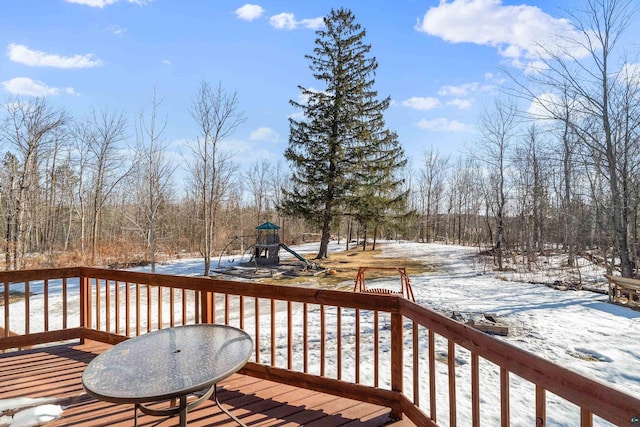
[{"left": 0, "top": 267, "right": 640, "bottom": 427}]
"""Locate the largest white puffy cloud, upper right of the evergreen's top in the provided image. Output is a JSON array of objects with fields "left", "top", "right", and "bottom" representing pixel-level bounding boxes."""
[{"left": 415, "top": 0, "right": 586, "bottom": 68}]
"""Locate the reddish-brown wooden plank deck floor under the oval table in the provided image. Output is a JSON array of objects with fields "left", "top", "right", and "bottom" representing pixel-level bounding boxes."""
[{"left": 0, "top": 341, "right": 414, "bottom": 427}]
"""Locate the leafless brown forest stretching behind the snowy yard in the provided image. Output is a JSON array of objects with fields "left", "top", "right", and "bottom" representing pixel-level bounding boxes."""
[{"left": 0, "top": 0, "right": 640, "bottom": 276}]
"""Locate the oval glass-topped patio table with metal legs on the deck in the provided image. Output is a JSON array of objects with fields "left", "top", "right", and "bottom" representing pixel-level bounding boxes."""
[{"left": 82, "top": 324, "right": 253, "bottom": 427}]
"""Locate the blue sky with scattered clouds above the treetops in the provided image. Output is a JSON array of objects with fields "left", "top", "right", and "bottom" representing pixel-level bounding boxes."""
[{"left": 0, "top": 0, "right": 640, "bottom": 173}]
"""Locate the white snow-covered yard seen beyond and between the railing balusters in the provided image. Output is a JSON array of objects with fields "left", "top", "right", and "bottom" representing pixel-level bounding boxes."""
[{"left": 0, "top": 242, "right": 640, "bottom": 426}]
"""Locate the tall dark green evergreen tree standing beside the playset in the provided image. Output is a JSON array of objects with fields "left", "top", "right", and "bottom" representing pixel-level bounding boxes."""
[{"left": 281, "top": 9, "right": 405, "bottom": 259}]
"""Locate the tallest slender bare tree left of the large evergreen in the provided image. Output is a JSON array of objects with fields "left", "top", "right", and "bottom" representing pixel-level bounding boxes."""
[{"left": 188, "top": 81, "right": 245, "bottom": 276}]
